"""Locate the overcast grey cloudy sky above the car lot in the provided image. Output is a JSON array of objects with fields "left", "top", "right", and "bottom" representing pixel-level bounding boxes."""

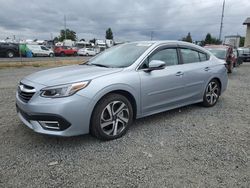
[{"left": 0, "top": 0, "right": 250, "bottom": 41}]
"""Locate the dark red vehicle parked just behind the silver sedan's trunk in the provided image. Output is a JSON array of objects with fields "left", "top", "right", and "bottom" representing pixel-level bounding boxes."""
[{"left": 204, "top": 45, "right": 237, "bottom": 73}]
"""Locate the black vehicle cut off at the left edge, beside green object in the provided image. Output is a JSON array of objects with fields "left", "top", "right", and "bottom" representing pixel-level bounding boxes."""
[{"left": 0, "top": 42, "right": 19, "bottom": 58}]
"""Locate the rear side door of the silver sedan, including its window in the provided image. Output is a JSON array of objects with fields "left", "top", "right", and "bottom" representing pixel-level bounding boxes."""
[{"left": 179, "top": 46, "right": 212, "bottom": 103}]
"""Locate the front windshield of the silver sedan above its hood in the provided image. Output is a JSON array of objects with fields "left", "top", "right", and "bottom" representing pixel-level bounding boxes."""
[{"left": 88, "top": 42, "right": 152, "bottom": 68}]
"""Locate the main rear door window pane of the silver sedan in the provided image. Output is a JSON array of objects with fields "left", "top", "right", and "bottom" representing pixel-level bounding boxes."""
[{"left": 181, "top": 48, "right": 200, "bottom": 64}]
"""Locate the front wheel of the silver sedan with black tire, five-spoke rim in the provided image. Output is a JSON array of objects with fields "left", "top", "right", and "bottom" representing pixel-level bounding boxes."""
[{"left": 90, "top": 94, "right": 133, "bottom": 140}]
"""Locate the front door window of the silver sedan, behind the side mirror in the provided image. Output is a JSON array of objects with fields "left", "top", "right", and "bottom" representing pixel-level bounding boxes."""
[{"left": 142, "top": 48, "right": 178, "bottom": 68}]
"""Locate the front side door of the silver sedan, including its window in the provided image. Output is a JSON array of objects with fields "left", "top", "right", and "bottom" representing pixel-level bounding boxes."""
[{"left": 139, "top": 46, "right": 184, "bottom": 115}]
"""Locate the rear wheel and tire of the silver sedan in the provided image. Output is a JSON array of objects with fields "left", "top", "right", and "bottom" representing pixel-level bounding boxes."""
[{"left": 202, "top": 79, "right": 221, "bottom": 107}]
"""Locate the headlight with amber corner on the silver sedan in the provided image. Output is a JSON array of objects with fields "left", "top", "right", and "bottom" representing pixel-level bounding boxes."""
[{"left": 41, "top": 81, "right": 89, "bottom": 98}]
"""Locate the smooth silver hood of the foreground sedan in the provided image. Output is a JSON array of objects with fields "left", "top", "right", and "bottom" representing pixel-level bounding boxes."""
[{"left": 25, "top": 65, "right": 123, "bottom": 86}]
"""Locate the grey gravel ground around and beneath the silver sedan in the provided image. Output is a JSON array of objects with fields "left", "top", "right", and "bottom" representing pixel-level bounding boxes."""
[{"left": 0, "top": 63, "right": 250, "bottom": 188}]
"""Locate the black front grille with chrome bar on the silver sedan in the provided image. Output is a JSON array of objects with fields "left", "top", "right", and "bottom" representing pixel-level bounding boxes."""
[{"left": 18, "top": 83, "right": 36, "bottom": 102}]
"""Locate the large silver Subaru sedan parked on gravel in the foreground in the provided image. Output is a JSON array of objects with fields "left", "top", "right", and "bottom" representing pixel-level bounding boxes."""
[{"left": 16, "top": 41, "right": 228, "bottom": 140}]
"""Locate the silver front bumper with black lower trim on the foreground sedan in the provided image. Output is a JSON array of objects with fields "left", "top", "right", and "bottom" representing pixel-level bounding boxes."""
[{"left": 16, "top": 79, "right": 91, "bottom": 136}]
